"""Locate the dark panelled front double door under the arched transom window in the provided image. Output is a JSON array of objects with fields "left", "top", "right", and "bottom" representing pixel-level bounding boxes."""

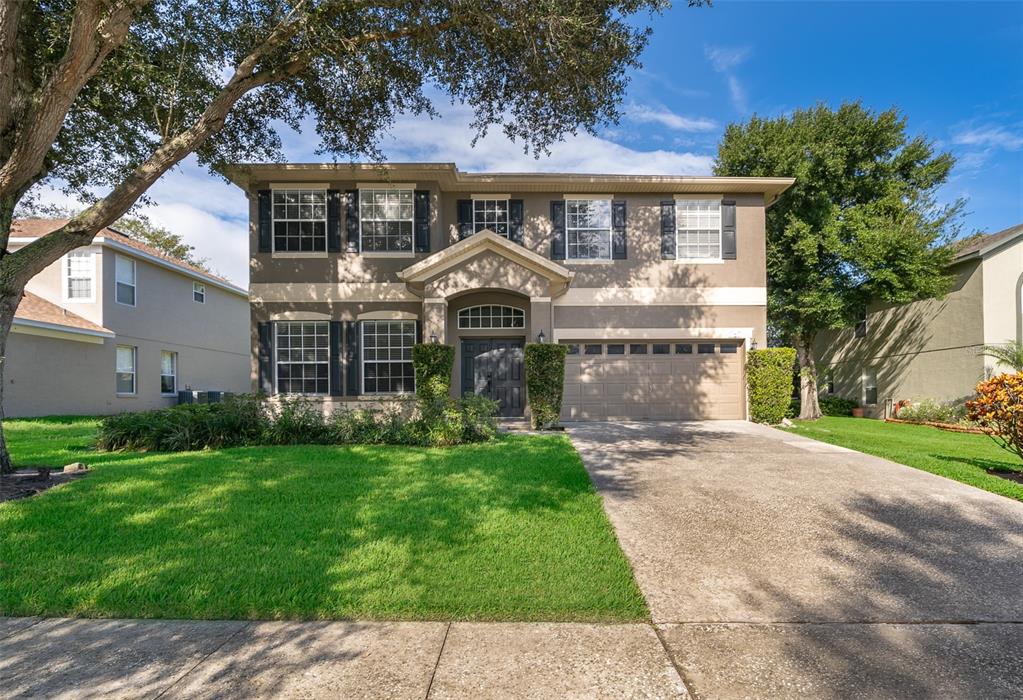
[{"left": 461, "top": 338, "right": 526, "bottom": 418}]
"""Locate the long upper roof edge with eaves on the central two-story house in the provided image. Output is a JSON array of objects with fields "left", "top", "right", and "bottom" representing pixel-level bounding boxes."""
[{"left": 223, "top": 163, "right": 795, "bottom": 202}]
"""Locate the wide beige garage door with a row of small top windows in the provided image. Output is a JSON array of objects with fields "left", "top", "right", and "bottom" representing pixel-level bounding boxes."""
[{"left": 562, "top": 341, "right": 746, "bottom": 421}]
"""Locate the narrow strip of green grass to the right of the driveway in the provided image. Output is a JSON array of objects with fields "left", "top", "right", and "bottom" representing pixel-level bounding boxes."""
[{"left": 790, "top": 417, "right": 1023, "bottom": 500}]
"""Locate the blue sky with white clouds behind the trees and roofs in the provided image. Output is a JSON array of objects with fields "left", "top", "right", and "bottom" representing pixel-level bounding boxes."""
[{"left": 28, "top": 0, "right": 1023, "bottom": 287}]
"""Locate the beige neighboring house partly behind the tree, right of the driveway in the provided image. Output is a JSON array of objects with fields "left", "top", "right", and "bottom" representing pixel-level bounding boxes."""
[{"left": 815, "top": 225, "right": 1023, "bottom": 417}]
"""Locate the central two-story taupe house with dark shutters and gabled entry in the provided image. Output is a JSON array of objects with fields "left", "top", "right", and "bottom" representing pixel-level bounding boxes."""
[{"left": 229, "top": 164, "right": 792, "bottom": 420}]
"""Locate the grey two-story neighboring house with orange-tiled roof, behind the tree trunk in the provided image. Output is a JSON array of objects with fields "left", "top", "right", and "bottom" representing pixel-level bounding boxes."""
[{"left": 3, "top": 219, "right": 250, "bottom": 417}]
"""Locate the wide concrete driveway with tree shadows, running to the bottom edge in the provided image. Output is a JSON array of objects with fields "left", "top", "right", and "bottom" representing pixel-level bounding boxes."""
[{"left": 570, "top": 422, "right": 1023, "bottom": 698}]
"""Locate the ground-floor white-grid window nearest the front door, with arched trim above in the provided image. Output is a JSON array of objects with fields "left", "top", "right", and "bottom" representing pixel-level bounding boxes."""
[{"left": 361, "top": 321, "right": 415, "bottom": 394}]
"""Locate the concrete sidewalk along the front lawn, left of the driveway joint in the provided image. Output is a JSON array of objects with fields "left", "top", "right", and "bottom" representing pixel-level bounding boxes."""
[{"left": 0, "top": 618, "right": 686, "bottom": 698}]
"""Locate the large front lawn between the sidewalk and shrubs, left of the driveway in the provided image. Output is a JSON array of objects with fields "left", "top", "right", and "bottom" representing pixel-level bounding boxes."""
[{"left": 0, "top": 419, "right": 648, "bottom": 621}]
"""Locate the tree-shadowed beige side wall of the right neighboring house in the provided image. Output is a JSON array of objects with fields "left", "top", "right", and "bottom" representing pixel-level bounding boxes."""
[{"left": 815, "top": 260, "right": 985, "bottom": 417}]
